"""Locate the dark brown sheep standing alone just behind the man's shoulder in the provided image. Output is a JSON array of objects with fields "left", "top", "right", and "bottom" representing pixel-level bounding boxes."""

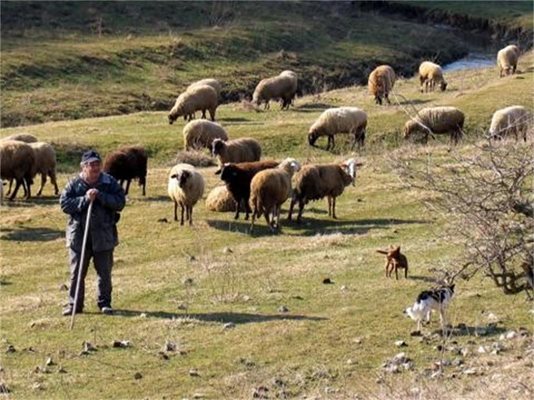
[{"left": 103, "top": 146, "right": 148, "bottom": 196}]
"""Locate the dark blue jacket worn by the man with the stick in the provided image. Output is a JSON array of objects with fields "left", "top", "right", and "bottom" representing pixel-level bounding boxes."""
[{"left": 59, "top": 172, "right": 126, "bottom": 252}]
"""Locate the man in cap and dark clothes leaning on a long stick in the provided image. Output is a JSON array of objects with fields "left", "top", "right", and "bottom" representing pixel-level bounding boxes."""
[{"left": 59, "top": 150, "right": 126, "bottom": 316}]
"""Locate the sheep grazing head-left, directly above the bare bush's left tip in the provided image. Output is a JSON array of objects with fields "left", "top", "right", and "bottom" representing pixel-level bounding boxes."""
[{"left": 404, "top": 107, "right": 465, "bottom": 144}]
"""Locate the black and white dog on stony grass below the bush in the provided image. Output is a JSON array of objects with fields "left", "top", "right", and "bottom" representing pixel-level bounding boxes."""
[{"left": 404, "top": 285, "right": 454, "bottom": 333}]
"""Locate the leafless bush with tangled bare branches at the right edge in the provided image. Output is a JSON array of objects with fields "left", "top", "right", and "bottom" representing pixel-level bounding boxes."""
[{"left": 392, "top": 140, "right": 534, "bottom": 298}]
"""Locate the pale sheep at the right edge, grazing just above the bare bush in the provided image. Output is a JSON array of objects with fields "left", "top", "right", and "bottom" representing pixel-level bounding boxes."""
[{"left": 489, "top": 106, "right": 531, "bottom": 141}]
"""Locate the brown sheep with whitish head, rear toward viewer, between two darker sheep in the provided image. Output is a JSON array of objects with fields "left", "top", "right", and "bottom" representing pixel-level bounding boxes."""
[{"left": 249, "top": 158, "right": 300, "bottom": 233}]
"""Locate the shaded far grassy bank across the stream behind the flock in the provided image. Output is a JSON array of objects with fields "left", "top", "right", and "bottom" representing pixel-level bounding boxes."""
[{"left": 4, "top": 2, "right": 532, "bottom": 127}]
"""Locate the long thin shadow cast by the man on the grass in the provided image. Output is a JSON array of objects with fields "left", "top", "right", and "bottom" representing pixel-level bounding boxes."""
[{"left": 113, "top": 309, "right": 327, "bottom": 324}]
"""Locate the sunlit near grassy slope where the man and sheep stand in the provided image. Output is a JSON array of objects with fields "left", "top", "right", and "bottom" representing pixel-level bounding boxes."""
[{"left": 0, "top": 53, "right": 534, "bottom": 399}]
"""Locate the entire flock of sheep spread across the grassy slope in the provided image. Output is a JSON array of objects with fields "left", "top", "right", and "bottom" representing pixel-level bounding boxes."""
[{"left": 0, "top": 45, "right": 530, "bottom": 231}]
